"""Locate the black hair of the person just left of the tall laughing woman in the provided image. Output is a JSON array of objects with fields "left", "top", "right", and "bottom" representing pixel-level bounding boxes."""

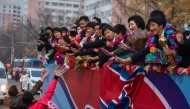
[{"left": 113, "top": 24, "right": 127, "bottom": 35}]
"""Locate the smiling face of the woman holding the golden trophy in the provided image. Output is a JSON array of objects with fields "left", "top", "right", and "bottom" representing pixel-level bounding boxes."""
[{"left": 150, "top": 22, "right": 163, "bottom": 36}]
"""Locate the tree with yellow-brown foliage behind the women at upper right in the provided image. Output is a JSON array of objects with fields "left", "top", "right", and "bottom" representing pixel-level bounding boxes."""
[{"left": 113, "top": 0, "right": 190, "bottom": 29}]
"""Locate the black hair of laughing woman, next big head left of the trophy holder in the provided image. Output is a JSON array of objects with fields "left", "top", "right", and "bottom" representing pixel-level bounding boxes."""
[{"left": 128, "top": 15, "right": 145, "bottom": 30}]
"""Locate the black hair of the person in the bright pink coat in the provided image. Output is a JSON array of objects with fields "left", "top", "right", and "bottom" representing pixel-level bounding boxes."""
[{"left": 22, "top": 91, "right": 34, "bottom": 106}]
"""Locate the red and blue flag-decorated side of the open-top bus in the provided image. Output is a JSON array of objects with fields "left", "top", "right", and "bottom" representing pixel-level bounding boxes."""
[{"left": 43, "top": 64, "right": 190, "bottom": 109}]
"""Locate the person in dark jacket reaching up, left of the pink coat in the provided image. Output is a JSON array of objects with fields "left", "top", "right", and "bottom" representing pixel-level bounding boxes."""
[{"left": 8, "top": 72, "right": 49, "bottom": 109}]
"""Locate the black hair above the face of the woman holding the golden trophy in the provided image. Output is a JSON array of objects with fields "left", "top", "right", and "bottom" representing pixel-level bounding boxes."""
[{"left": 148, "top": 10, "right": 167, "bottom": 28}]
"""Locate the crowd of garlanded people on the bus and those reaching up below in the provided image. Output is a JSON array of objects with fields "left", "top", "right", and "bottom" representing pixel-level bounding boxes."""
[{"left": 4, "top": 10, "right": 190, "bottom": 109}]
